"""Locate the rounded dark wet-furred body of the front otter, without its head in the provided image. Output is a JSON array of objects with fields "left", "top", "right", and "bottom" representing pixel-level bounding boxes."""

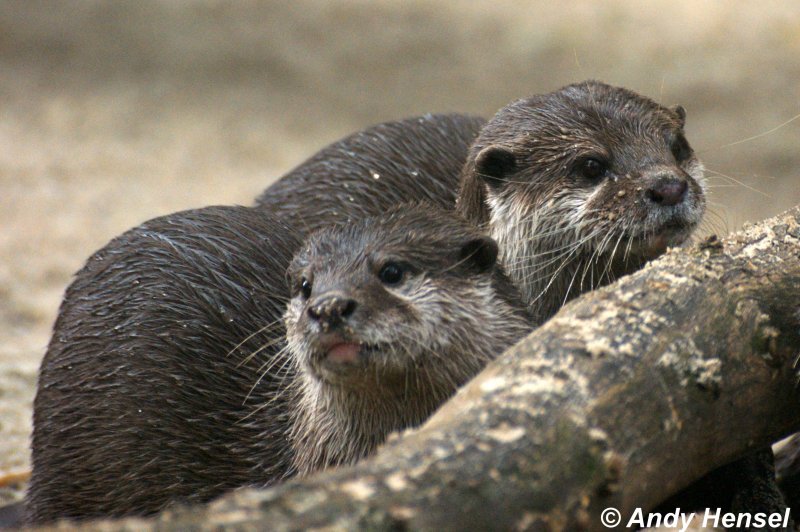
[{"left": 26, "top": 207, "right": 302, "bottom": 523}]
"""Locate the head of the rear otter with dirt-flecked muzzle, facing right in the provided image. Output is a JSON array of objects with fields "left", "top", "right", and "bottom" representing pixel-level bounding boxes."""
[{"left": 458, "top": 81, "right": 705, "bottom": 321}]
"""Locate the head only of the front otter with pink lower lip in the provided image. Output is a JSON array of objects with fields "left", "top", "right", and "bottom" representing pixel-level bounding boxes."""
[{"left": 285, "top": 206, "right": 528, "bottom": 396}]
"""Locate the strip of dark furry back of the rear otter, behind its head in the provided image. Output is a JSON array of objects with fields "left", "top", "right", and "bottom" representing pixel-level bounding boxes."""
[{"left": 257, "top": 114, "right": 485, "bottom": 234}]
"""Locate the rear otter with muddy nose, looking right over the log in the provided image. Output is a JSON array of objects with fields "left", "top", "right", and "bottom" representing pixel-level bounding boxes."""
[{"left": 256, "top": 81, "right": 705, "bottom": 323}]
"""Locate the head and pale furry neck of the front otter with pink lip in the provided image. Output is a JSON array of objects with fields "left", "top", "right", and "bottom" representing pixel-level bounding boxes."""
[{"left": 285, "top": 206, "right": 532, "bottom": 475}]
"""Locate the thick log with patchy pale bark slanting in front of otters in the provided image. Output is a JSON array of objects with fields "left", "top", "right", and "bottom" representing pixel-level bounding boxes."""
[{"left": 50, "top": 209, "right": 800, "bottom": 530}]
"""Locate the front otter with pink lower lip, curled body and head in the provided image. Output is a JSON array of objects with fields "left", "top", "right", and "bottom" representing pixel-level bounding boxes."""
[{"left": 26, "top": 202, "right": 530, "bottom": 523}]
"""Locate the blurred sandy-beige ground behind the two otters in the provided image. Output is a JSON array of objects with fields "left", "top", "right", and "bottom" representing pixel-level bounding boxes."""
[{"left": 0, "top": 0, "right": 800, "bottom": 503}]
